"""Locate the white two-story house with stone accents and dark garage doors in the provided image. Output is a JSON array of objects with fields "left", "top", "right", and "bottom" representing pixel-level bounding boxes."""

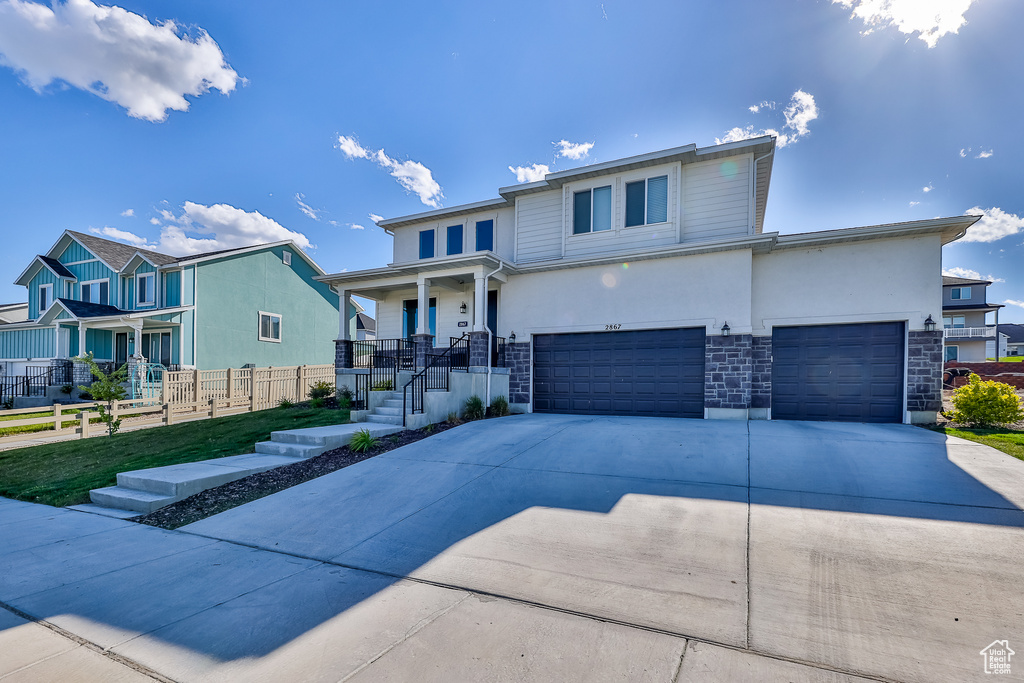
[{"left": 319, "top": 136, "right": 978, "bottom": 422}]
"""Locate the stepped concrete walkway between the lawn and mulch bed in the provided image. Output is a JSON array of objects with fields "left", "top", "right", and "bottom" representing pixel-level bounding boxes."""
[{"left": 81, "top": 421, "right": 401, "bottom": 517}]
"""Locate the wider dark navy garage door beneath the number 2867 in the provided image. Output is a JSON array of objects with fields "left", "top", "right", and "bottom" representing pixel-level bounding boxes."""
[{"left": 534, "top": 328, "right": 705, "bottom": 418}]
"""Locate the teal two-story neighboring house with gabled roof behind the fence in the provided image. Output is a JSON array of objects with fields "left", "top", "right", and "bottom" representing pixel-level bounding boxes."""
[{"left": 0, "top": 230, "right": 354, "bottom": 375}]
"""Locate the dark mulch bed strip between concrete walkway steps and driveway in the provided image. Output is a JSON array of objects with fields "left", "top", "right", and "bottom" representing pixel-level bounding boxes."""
[{"left": 131, "top": 422, "right": 457, "bottom": 528}]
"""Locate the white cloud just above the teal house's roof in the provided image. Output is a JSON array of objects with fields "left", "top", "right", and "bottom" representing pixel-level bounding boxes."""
[{"left": 107, "top": 202, "right": 314, "bottom": 256}]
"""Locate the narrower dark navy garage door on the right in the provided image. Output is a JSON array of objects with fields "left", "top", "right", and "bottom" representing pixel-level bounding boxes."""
[{"left": 771, "top": 323, "right": 904, "bottom": 422}]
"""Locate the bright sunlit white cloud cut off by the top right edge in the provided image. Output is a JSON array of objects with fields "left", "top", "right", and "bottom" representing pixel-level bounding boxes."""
[{"left": 833, "top": 0, "right": 975, "bottom": 47}]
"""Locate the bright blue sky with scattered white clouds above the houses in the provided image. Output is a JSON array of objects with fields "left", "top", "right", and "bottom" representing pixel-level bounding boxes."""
[{"left": 0, "top": 0, "right": 1024, "bottom": 323}]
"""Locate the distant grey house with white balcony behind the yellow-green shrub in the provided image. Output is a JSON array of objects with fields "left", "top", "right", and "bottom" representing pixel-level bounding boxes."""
[{"left": 942, "top": 275, "right": 1002, "bottom": 362}]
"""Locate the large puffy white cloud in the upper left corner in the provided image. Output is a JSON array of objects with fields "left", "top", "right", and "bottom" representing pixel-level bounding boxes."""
[{"left": 0, "top": 0, "right": 239, "bottom": 121}]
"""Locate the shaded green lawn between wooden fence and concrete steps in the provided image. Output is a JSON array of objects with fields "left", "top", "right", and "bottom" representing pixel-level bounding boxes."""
[{"left": 0, "top": 408, "right": 348, "bottom": 506}]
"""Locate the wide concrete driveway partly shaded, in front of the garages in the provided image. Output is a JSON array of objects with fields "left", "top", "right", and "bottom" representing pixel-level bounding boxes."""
[{"left": 0, "top": 415, "right": 1024, "bottom": 681}]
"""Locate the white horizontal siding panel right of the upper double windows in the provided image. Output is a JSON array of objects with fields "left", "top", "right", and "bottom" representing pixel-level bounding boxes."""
[{"left": 683, "top": 155, "right": 751, "bottom": 242}]
